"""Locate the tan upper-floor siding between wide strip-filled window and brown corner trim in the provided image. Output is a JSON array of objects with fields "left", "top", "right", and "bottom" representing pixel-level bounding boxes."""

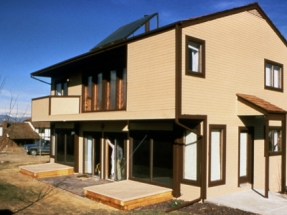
[{"left": 127, "top": 30, "right": 175, "bottom": 117}]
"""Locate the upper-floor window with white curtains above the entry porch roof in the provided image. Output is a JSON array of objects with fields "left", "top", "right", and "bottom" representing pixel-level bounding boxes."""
[{"left": 265, "top": 60, "right": 283, "bottom": 91}]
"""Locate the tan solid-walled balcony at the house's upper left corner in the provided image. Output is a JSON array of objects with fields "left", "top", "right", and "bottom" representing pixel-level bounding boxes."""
[{"left": 32, "top": 96, "right": 80, "bottom": 121}]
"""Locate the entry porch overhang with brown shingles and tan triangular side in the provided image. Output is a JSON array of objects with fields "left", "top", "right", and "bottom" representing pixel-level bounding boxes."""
[{"left": 236, "top": 93, "right": 287, "bottom": 116}]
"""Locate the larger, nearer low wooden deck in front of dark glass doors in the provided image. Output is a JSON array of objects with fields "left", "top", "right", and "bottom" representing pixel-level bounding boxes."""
[{"left": 84, "top": 180, "right": 173, "bottom": 210}]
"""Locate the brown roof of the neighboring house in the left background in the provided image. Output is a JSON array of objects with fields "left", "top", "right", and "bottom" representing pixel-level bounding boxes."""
[{"left": 5, "top": 122, "right": 40, "bottom": 140}]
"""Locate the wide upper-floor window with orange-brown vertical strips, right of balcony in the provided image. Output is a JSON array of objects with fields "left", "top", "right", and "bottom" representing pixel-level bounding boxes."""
[{"left": 83, "top": 68, "right": 127, "bottom": 111}]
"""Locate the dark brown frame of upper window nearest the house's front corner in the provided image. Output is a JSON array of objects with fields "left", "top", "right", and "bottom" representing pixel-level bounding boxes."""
[{"left": 185, "top": 35, "right": 205, "bottom": 78}]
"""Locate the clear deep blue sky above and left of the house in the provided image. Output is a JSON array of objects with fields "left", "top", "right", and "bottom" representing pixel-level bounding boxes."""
[{"left": 0, "top": 0, "right": 287, "bottom": 115}]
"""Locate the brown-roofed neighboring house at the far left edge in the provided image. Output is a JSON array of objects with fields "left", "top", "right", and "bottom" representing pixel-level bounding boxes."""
[{"left": 0, "top": 120, "right": 40, "bottom": 151}]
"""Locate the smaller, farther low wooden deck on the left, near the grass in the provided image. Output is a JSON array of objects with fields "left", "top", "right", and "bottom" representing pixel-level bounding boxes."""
[{"left": 19, "top": 163, "right": 74, "bottom": 179}]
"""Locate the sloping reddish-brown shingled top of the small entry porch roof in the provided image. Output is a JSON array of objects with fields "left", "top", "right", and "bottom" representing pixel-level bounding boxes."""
[{"left": 236, "top": 93, "right": 286, "bottom": 114}]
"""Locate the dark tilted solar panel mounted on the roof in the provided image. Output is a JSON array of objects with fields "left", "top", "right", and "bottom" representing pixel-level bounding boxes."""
[{"left": 90, "top": 13, "right": 157, "bottom": 51}]
